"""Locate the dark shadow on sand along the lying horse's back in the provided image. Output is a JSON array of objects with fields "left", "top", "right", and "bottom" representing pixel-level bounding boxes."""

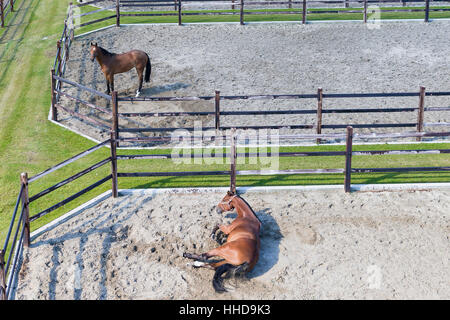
[{"left": 226, "top": 208, "right": 283, "bottom": 279}]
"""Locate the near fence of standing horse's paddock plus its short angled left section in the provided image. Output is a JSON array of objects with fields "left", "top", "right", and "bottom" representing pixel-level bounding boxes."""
[{"left": 51, "top": 70, "right": 450, "bottom": 143}]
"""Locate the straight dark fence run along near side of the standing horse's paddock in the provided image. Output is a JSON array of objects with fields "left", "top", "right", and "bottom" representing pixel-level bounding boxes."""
[{"left": 111, "top": 87, "right": 450, "bottom": 143}]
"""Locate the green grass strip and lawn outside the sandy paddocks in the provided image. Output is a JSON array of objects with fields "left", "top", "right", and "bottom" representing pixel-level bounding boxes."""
[{"left": 0, "top": 0, "right": 450, "bottom": 250}]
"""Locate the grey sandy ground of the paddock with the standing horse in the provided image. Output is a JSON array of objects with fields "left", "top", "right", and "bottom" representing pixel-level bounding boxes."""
[{"left": 60, "top": 22, "right": 450, "bottom": 144}]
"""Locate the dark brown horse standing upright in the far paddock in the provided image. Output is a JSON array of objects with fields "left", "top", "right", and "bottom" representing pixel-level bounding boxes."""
[{"left": 90, "top": 42, "right": 152, "bottom": 97}]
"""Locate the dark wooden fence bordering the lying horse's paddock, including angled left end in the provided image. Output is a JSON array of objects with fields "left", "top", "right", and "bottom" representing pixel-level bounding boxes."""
[{"left": 0, "top": 127, "right": 450, "bottom": 300}]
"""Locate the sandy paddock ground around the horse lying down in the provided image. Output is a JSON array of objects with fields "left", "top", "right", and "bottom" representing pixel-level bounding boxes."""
[{"left": 16, "top": 190, "right": 450, "bottom": 299}]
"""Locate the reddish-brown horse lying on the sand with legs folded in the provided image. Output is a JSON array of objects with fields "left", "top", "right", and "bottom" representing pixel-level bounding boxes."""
[{"left": 183, "top": 191, "right": 261, "bottom": 293}]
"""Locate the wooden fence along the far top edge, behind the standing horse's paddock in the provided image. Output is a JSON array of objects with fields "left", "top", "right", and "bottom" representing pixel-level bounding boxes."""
[{"left": 75, "top": 0, "right": 450, "bottom": 28}]
